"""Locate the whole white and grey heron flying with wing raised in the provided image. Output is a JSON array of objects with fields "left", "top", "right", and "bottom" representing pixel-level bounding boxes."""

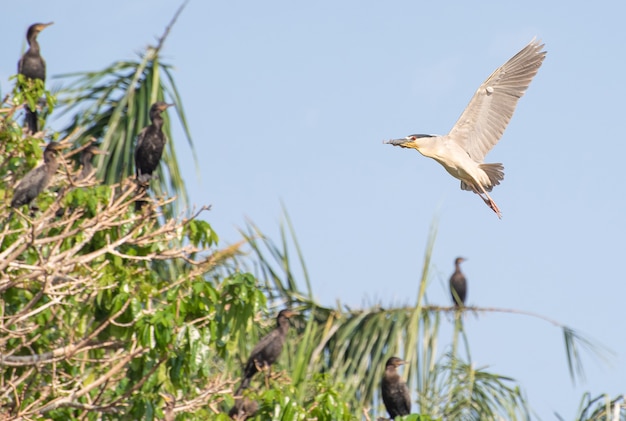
[{"left": 386, "top": 40, "right": 546, "bottom": 218}]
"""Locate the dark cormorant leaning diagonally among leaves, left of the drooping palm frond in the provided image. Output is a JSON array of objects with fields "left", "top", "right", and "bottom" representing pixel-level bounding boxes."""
[{"left": 235, "top": 309, "right": 298, "bottom": 395}]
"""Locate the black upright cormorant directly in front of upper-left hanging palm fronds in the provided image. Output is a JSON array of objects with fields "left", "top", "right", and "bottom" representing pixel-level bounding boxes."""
[{"left": 135, "top": 102, "right": 174, "bottom": 183}]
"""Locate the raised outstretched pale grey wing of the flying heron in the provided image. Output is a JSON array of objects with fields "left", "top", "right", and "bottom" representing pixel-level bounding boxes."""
[{"left": 449, "top": 39, "right": 546, "bottom": 162}]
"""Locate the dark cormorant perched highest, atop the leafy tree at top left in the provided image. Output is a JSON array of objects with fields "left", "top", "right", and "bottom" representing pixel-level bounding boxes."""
[{"left": 17, "top": 22, "right": 53, "bottom": 133}]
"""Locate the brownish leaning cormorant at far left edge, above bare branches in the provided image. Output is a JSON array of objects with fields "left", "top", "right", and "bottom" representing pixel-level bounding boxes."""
[{"left": 11, "top": 142, "right": 64, "bottom": 208}]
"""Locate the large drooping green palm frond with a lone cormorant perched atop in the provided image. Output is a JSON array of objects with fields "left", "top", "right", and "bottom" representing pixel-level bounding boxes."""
[{"left": 238, "top": 218, "right": 608, "bottom": 420}]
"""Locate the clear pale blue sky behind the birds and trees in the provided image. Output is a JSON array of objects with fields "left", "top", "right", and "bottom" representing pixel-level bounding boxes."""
[{"left": 0, "top": 0, "right": 626, "bottom": 420}]
